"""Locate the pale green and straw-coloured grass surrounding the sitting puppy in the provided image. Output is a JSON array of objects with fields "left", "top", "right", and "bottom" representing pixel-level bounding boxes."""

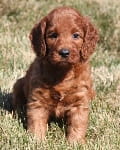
[{"left": 0, "top": 0, "right": 120, "bottom": 150}]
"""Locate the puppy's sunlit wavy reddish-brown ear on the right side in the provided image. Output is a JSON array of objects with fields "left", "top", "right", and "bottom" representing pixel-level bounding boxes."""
[{"left": 80, "top": 18, "right": 99, "bottom": 61}]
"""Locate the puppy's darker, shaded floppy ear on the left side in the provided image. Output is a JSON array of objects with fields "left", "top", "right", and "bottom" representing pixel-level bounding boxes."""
[{"left": 29, "top": 17, "right": 46, "bottom": 57}]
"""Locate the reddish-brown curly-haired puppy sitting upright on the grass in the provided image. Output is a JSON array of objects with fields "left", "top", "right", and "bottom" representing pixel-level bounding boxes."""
[{"left": 13, "top": 7, "right": 98, "bottom": 143}]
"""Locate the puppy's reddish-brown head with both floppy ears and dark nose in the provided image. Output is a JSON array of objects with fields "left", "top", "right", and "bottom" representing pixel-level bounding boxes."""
[{"left": 30, "top": 7, "right": 98, "bottom": 64}]
